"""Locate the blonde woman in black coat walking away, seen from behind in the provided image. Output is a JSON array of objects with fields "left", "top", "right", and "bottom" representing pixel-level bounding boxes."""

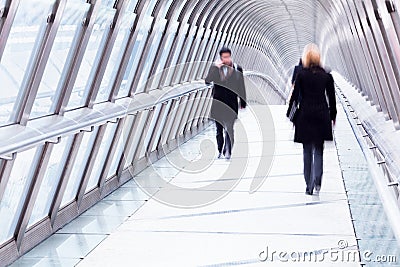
[{"left": 286, "top": 44, "right": 337, "bottom": 195}]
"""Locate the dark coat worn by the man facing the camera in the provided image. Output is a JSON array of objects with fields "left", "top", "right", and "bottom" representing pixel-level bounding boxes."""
[{"left": 205, "top": 65, "right": 246, "bottom": 122}]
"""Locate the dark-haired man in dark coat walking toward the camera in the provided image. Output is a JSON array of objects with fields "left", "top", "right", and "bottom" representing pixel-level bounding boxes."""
[{"left": 205, "top": 47, "right": 246, "bottom": 159}]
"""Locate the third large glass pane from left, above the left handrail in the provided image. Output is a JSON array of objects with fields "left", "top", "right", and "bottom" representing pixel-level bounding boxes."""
[{"left": 67, "top": 7, "right": 116, "bottom": 110}]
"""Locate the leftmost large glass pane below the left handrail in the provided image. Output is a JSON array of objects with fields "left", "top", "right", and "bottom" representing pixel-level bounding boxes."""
[{"left": 0, "top": 148, "right": 41, "bottom": 244}]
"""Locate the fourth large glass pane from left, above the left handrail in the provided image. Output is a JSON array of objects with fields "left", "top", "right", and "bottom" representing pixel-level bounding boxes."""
[{"left": 96, "top": 13, "right": 135, "bottom": 103}]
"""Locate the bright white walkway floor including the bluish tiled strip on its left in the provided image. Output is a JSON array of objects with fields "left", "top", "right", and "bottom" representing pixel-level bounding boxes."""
[{"left": 14, "top": 106, "right": 388, "bottom": 266}]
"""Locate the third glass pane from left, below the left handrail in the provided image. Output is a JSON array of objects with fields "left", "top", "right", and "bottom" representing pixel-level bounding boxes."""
[{"left": 61, "top": 128, "right": 99, "bottom": 207}]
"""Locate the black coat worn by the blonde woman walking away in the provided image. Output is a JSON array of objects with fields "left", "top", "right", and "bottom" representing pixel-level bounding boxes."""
[{"left": 286, "top": 67, "right": 337, "bottom": 144}]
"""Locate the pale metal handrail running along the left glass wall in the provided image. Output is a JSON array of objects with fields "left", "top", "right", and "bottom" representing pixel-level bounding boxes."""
[{"left": 0, "top": 81, "right": 210, "bottom": 157}]
